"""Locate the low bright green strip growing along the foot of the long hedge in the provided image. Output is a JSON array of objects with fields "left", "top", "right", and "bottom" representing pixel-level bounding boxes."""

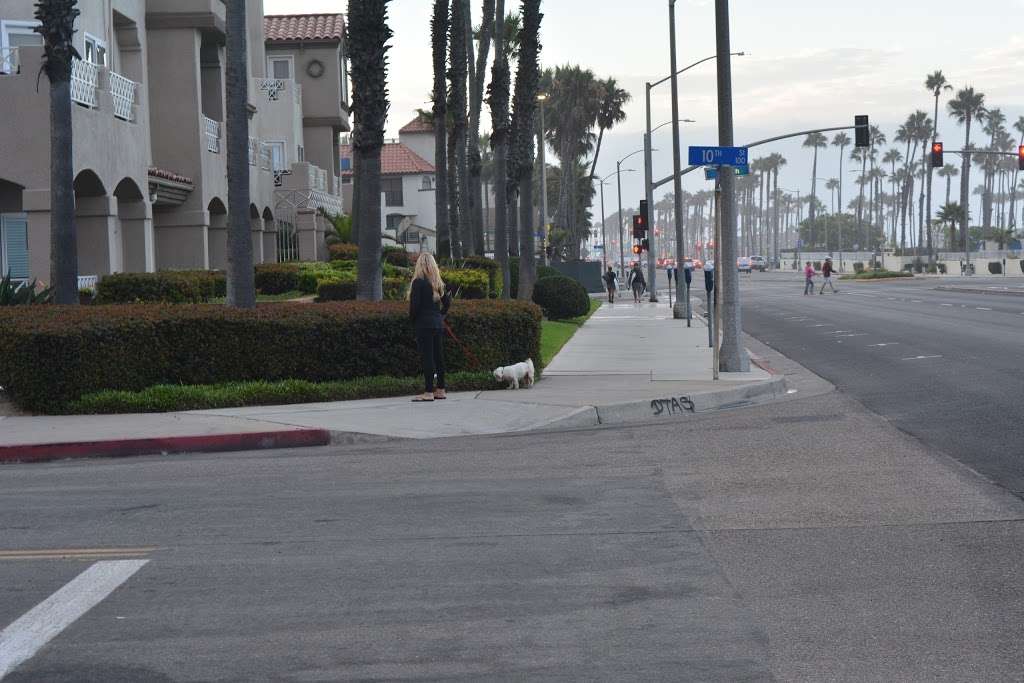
[{"left": 68, "top": 373, "right": 503, "bottom": 415}]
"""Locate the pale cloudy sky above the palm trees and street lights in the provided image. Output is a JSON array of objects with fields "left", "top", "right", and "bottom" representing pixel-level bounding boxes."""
[{"left": 264, "top": 0, "right": 1024, "bottom": 213}]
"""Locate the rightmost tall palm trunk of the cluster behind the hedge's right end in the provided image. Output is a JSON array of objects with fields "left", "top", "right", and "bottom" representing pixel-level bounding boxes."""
[{"left": 505, "top": 0, "right": 544, "bottom": 301}]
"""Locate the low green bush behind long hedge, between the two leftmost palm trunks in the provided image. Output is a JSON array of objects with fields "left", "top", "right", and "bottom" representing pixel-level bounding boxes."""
[{"left": 95, "top": 270, "right": 226, "bottom": 304}]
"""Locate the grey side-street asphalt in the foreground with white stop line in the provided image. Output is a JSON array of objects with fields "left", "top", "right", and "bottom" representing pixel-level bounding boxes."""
[{"left": 0, "top": 350, "right": 1024, "bottom": 683}]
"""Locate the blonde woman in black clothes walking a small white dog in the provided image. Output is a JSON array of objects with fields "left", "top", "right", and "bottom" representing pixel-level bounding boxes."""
[{"left": 409, "top": 254, "right": 451, "bottom": 403}]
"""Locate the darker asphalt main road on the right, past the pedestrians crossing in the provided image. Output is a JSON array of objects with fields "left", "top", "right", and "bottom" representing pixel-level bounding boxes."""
[{"left": 742, "top": 274, "right": 1024, "bottom": 496}]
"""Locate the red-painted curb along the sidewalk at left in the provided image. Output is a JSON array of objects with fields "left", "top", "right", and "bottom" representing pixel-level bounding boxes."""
[{"left": 0, "top": 429, "right": 331, "bottom": 464}]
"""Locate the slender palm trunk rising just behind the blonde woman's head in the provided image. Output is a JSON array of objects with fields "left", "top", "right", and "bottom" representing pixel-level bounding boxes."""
[{"left": 430, "top": 0, "right": 452, "bottom": 258}]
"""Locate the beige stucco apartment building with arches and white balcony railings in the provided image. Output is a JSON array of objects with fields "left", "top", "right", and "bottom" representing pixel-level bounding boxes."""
[{"left": 0, "top": 0, "right": 349, "bottom": 282}]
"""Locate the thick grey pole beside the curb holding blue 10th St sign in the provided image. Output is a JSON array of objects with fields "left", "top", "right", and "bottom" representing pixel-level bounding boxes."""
[{"left": 715, "top": 0, "right": 751, "bottom": 373}]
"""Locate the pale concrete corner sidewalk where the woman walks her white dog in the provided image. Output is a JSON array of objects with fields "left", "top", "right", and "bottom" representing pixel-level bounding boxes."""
[{"left": 0, "top": 296, "right": 785, "bottom": 462}]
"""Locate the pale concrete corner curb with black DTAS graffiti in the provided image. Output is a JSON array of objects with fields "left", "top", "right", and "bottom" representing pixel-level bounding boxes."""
[{"left": 596, "top": 376, "right": 786, "bottom": 425}]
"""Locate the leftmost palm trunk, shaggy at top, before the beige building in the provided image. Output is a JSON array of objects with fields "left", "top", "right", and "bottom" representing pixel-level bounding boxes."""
[{"left": 36, "top": 0, "right": 79, "bottom": 305}]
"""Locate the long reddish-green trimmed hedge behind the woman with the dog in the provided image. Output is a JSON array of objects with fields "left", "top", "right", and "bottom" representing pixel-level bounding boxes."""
[{"left": 0, "top": 301, "right": 541, "bottom": 413}]
